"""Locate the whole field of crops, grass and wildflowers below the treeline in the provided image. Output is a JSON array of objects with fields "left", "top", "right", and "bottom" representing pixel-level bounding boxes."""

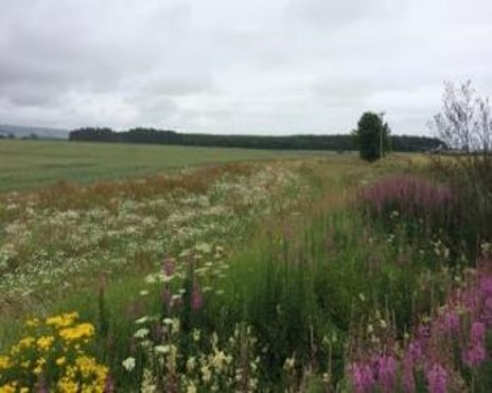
[{"left": 0, "top": 145, "right": 492, "bottom": 393}]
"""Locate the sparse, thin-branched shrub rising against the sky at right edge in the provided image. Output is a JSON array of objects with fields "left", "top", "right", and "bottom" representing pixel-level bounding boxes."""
[{"left": 431, "top": 81, "right": 492, "bottom": 251}]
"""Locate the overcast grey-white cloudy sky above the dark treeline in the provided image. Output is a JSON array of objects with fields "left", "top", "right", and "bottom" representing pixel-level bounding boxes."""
[{"left": 0, "top": 0, "right": 492, "bottom": 135}]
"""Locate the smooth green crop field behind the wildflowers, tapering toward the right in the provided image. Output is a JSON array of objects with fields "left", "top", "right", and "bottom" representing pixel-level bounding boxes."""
[{"left": 0, "top": 140, "right": 330, "bottom": 192}]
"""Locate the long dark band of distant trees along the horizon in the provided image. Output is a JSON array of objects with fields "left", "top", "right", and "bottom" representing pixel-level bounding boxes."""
[{"left": 69, "top": 128, "right": 440, "bottom": 152}]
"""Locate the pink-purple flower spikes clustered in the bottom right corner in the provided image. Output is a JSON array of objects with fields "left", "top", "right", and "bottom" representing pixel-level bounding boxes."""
[{"left": 348, "top": 260, "right": 492, "bottom": 393}]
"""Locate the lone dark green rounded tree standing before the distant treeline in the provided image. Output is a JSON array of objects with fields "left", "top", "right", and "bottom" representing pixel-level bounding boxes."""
[{"left": 353, "top": 112, "right": 390, "bottom": 162}]
